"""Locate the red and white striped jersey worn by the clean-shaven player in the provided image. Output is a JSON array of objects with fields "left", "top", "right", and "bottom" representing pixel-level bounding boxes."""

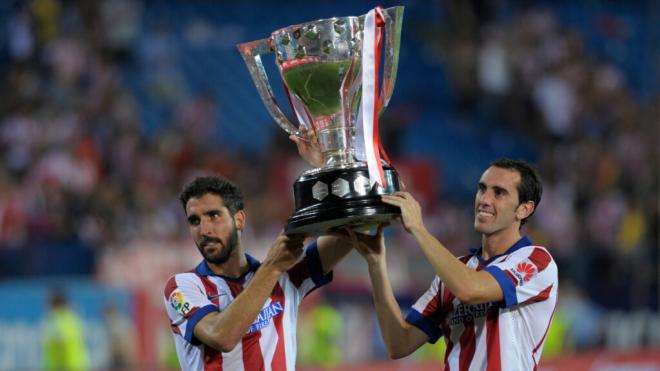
[{"left": 406, "top": 237, "right": 558, "bottom": 371}]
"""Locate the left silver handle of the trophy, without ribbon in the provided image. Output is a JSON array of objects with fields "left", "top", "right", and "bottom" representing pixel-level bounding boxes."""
[{"left": 238, "top": 39, "right": 308, "bottom": 140}]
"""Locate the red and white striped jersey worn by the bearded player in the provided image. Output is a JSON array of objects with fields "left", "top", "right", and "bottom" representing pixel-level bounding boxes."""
[{"left": 164, "top": 242, "right": 332, "bottom": 371}]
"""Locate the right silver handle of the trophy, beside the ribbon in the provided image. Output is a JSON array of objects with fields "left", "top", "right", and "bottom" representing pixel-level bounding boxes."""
[{"left": 378, "top": 6, "right": 403, "bottom": 117}]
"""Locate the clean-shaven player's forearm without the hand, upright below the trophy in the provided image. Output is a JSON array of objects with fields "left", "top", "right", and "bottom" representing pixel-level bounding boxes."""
[{"left": 369, "top": 262, "right": 419, "bottom": 358}]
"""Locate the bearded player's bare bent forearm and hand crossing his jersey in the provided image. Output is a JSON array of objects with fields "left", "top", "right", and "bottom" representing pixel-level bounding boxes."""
[{"left": 194, "top": 234, "right": 304, "bottom": 352}]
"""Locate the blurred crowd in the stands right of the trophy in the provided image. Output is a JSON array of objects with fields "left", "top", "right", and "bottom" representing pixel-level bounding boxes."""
[{"left": 435, "top": 2, "right": 660, "bottom": 309}]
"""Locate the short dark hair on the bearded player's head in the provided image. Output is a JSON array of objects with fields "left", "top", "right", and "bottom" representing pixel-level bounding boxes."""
[{"left": 179, "top": 175, "right": 245, "bottom": 215}]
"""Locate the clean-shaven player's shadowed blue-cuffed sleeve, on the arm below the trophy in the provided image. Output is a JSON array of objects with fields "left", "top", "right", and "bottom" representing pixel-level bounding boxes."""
[{"left": 406, "top": 276, "right": 442, "bottom": 343}]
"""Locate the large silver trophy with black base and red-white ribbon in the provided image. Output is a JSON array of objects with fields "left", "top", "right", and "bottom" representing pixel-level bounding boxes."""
[{"left": 238, "top": 7, "right": 403, "bottom": 234}]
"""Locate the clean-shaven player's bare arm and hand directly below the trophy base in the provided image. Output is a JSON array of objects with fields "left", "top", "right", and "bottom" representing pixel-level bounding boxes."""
[{"left": 351, "top": 225, "right": 429, "bottom": 359}]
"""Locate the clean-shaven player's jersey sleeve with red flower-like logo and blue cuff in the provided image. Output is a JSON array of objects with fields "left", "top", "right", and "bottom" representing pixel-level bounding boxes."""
[{"left": 484, "top": 246, "right": 557, "bottom": 307}]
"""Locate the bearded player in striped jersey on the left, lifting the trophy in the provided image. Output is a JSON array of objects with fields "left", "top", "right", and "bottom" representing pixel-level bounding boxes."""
[{"left": 164, "top": 176, "right": 352, "bottom": 370}]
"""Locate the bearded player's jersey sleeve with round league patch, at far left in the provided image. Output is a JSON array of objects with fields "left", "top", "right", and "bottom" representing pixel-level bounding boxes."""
[{"left": 164, "top": 273, "right": 219, "bottom": 345}]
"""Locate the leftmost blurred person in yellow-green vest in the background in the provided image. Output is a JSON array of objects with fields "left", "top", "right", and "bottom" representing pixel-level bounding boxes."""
[{"left": 43, "top": 288, "right": 90, "bottom": 371}]
